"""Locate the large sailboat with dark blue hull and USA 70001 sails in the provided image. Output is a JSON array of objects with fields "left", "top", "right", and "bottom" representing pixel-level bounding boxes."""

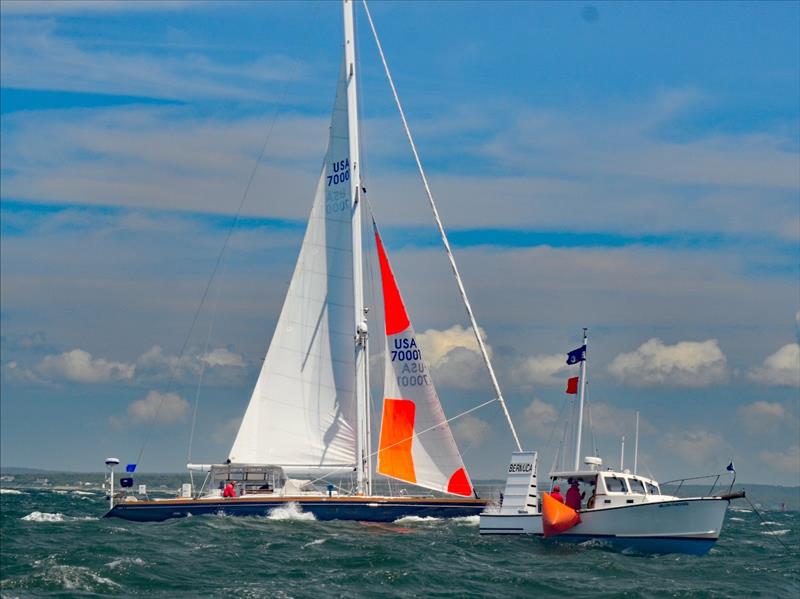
[{"left": 106, "top": 0, "right": 496, "bottom": 522}]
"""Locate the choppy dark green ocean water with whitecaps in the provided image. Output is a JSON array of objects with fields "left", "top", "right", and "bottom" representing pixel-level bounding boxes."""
[{"left": 0, "top": 475, "right": 800, "bottom": 598}]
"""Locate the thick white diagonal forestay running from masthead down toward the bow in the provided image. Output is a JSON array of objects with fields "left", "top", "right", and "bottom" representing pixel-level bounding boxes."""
[{"left": 362, "top": 0, "right": 522, "bottom": 451}]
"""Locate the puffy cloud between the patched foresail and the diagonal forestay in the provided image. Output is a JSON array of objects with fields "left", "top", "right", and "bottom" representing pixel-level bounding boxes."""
[{"left": 417, "top": 325, "right": 492, "bottom": 389}]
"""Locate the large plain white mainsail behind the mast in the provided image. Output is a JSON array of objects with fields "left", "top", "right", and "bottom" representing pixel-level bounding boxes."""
[{"left": 229, "top": 57, "right": 356, "bottom": 467}]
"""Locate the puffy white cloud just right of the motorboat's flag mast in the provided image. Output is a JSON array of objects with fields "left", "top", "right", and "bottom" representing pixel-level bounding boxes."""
[{"left": 608, "top": 338, "right": 727, "bottom": 387}]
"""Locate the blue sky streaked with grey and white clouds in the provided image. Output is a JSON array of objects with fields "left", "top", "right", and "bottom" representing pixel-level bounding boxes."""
[{"left": 0, "top": 1, "right": 800, "bottom": 484}]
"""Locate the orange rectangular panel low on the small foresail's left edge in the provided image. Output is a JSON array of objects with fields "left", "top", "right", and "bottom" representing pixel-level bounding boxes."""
[{"left": 378, "top": 398, "right": 417, "bottom": 483}]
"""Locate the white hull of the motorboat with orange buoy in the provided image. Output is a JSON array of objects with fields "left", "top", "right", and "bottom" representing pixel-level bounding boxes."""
[{"left": 480, "top": 497, "right": 729, "bottom": 555}]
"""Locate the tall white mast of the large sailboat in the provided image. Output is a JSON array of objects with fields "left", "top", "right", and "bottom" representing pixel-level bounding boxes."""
[{"left": 343, "top": 0, "right": 370, "bottom": 494}]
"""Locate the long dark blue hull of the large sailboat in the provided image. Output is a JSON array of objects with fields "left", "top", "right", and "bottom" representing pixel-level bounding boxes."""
[{"left": 105, "top": 498, "right": 486, "bottom": 522}]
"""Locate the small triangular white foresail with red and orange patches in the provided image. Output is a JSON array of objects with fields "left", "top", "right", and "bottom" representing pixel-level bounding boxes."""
[{"left": 375, "top": 230, "right": 472, "bottom": 496}]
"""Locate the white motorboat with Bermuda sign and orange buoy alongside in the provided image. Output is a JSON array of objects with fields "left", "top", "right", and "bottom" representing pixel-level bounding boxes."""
[{"left": 480, "top": 329, "right": 744, "bottom": 555}]
